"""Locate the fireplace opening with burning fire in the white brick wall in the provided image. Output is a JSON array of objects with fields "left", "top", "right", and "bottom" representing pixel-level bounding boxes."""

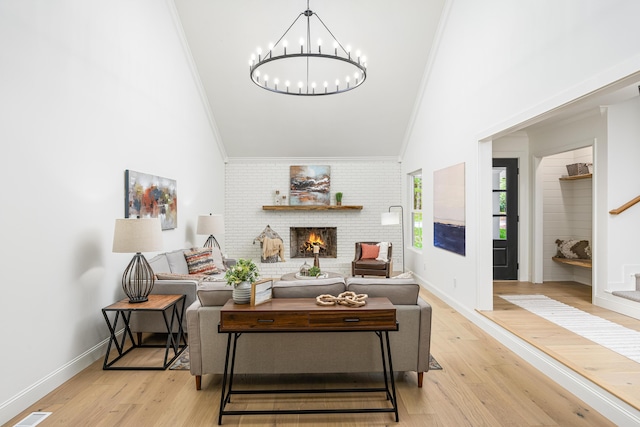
[{"left": 289, "top": 227, "right": 338, "bottom": 258}]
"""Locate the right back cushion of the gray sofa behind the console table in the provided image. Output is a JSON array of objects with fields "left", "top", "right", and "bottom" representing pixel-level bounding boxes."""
[{"left": 347, "top": 277, "right": 420, "bottom": 305}]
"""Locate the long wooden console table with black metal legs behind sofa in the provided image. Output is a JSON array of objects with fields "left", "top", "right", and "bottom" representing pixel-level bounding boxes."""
[{"left": 218, "top": 298, "right": 398, "bottom": 425}]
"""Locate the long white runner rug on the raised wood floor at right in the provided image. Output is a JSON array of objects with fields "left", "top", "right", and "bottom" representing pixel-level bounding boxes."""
[{"left": 500, "top": 295, "right": 640, "bottom": 363}]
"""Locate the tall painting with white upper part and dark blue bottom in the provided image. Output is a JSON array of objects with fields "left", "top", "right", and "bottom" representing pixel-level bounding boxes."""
[{"left": 433, "top": 163, "right": 465, "bottom": 255}]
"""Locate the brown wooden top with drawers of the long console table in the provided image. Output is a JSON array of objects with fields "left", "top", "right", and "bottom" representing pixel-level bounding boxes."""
[{"left": 218, "top": 298, "right": 398, "bottom": 333}]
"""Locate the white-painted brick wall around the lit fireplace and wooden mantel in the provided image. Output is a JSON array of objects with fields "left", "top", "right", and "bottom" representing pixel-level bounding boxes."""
[{"left": 226, "top": 159, "right": 400, "bottom": 277}]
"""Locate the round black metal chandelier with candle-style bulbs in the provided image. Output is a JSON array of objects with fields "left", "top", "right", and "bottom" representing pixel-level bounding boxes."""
[{"left": 249, "top": 0, "right": 367, "bottom": 96}]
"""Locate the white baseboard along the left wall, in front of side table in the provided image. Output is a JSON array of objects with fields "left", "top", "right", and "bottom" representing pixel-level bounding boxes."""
[{"left": 0, "top": 338, "right": 109, "bottom": 425}]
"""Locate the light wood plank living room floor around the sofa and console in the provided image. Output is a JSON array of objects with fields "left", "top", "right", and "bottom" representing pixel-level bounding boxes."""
[{"left": 6, "top": 292, "right": 613, "bottom": 427}]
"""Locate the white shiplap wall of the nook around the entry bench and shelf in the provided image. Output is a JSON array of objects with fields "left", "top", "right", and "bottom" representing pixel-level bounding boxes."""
[{"left": 542, "top": 147, "right": 593, "bottom": 285}]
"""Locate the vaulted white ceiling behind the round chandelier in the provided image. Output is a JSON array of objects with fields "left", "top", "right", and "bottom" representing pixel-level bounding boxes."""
[{"left": 174, "top": 0, "right": 444, "bottom": 158}]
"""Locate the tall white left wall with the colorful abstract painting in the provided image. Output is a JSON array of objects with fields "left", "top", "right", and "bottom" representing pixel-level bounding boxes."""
[{"left": 0, "top": 0, "right": 224, "bottom": 424}]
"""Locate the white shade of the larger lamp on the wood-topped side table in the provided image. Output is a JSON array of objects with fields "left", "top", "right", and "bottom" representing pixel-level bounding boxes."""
[{"left": 113, "top": 218, "right": 163, "bottom": 253}]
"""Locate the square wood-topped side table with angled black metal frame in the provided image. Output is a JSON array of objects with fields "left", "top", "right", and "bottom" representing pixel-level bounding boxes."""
[{"left": 102, "top": 294, "right": 187, "bottom": 370}]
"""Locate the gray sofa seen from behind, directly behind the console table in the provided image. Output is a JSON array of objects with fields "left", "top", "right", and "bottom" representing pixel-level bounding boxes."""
[{"left": 186, "top": 277, "right": 431, "bottom": 390}]
